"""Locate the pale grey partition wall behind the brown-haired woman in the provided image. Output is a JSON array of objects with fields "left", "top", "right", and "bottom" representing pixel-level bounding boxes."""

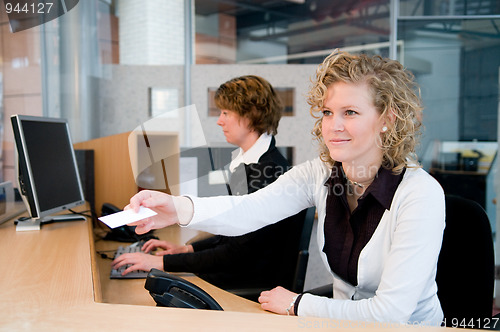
[{"left": 95, "top": 65, "right": 317, "bottom": 163}]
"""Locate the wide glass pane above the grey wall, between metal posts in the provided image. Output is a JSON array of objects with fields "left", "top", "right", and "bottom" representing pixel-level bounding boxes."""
[{"left": 195, "top": 0, "right": 390, "bottom": 64}]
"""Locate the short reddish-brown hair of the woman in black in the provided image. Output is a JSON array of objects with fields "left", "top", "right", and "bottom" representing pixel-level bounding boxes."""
[{"left": 215, "top": 75, "right": 283, "bottom": 135}]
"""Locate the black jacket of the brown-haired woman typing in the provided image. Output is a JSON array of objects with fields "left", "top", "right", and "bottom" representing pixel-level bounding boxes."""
[{"left": 163, "top": 138, "right": 305, "bottom": 290}]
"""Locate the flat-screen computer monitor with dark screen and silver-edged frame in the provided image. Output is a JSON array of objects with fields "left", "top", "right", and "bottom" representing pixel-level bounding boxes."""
[{"left": 11, "top": 115, "right": 85, "bottom": 227}]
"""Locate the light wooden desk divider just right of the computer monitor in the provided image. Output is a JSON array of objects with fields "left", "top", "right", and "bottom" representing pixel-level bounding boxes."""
[{"left": 74, "top": 131, "right": 180, "bottom": 214}]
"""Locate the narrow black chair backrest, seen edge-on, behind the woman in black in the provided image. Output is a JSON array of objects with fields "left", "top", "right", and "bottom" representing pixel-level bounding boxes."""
[{"left": 291, "top": 207, "right": 316, "bottom": 293}]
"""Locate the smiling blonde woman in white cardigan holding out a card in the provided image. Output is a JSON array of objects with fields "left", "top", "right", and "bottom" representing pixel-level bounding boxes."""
[{"left": 123, "top": 52, "right": 445, "bottom": 325}]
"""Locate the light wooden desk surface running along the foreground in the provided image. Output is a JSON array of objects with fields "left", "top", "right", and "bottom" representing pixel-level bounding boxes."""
[{"left": 0, "top": 214, "right": 448, "bottom": 332}]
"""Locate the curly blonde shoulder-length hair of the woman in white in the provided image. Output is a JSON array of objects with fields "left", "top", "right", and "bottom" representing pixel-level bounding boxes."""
[{"left": 307, "top": 51, "right": 423, "bottom": 174}]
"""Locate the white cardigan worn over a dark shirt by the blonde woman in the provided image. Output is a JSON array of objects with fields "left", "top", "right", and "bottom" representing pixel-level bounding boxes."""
[{"left": 188, "top": 158, "right": 445, "bottom": 325}]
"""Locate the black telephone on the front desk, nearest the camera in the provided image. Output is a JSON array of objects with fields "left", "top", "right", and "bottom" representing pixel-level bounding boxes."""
[{"left": 144, "top": 269, "right": 223, "bottom": 310}]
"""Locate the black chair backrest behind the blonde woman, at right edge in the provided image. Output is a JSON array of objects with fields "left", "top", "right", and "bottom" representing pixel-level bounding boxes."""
[{"left": 436, "top": 195, "right": 495, "bottom": 327}]
